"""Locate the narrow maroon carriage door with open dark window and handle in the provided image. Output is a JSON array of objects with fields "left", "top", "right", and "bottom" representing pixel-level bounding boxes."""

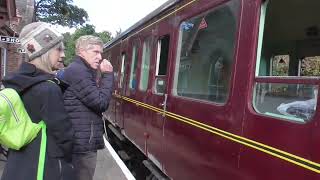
[{"left": 147, "top": 34, "right": 170, "bottom": 169}]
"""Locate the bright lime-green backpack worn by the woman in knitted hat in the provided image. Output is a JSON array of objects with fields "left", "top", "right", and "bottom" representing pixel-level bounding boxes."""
[{"left": 0, "top": 88, "right": 47, "bottom": 180}]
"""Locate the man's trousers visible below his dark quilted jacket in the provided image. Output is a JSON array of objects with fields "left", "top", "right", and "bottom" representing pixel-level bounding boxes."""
[{"left": 72, "top": 152, "right": 97, "bottom": 180}]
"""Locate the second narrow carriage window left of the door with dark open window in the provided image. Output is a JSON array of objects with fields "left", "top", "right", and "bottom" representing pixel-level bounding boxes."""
[{"left": 129, "top": 43, "right": 138, "bottom": 89}]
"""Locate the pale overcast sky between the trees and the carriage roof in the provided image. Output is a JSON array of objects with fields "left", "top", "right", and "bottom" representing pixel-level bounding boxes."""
[{"left": 68, "top": 0, "right": 167, "bottom": 35}]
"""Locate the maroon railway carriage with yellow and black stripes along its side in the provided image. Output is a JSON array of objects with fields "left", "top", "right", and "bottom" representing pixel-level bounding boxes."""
[{"left": 104, "top": 0, "right": 320, "bottom": 180}]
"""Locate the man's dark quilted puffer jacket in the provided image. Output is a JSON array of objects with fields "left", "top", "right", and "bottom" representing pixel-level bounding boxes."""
[{"left": 62, "top": 57, "right": 113, "bottom": 153}]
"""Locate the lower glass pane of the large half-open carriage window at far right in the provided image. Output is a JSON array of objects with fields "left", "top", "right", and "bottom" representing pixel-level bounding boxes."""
[{"left": 254, "top": 83, "right": 318, "bottom": 122}]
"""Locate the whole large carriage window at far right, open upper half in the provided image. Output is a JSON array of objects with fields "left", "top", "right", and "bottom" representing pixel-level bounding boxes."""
[{"left": 253, "top": 0, "right": 320, "bottom": 123}]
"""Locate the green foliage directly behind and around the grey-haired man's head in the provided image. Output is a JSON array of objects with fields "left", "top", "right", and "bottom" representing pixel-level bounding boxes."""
[{"left": 63, "top": 24, "right": 112, "bottom": 65}]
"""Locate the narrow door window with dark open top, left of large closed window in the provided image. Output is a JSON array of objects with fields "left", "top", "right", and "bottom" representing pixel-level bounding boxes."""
[{"left": 154, "top": 35, "right": 170, "bottom": 94}]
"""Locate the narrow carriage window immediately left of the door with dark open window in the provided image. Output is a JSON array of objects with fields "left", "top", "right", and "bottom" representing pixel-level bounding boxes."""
[{"left": 139, "top": 38, "right": 151, "bottom": 91}]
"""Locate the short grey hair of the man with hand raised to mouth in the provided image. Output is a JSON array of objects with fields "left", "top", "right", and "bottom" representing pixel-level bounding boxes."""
[{"left": 76, "top": 35, "right": 103, "bottom": 55}]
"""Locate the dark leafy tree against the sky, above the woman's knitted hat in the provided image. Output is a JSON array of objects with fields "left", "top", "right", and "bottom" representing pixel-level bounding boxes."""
[{"left": 34, "top": 0, "right": 88, "bottom": 28}]
